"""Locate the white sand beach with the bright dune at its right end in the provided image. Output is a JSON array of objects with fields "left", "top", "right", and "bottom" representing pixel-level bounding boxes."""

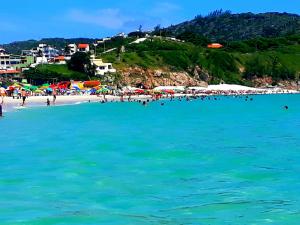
[{"left": 3, "top": 84, "right": 299, "bottom": 112}]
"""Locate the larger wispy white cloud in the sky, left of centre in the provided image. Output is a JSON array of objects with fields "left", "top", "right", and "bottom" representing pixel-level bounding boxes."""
[{"left": 68, "top": 9, "right": 133, "bottom": 29}]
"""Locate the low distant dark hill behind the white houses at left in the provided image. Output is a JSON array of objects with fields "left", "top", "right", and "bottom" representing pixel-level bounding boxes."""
[{"left": 0, "top": 38, "right": 95, "bottom": 54}]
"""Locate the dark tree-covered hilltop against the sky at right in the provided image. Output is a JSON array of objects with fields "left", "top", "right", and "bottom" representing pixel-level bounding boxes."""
[{"left": 159, "top": 10, "right": 300, "bottom": 42}]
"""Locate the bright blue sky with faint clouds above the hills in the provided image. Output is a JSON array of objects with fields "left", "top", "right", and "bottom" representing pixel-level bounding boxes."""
[{"left": 0, "top": 0, "right": 300, "bottom": 44}]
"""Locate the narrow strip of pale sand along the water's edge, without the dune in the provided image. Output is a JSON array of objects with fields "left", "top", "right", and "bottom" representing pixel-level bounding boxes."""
[{"left": 0, "top": 91, "right": 300, "bottom": 113}]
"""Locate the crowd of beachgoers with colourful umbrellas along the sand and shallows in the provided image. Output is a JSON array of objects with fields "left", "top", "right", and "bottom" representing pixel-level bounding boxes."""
[{"left": 0, "top": 80, "right": 295, "bottom": 116}]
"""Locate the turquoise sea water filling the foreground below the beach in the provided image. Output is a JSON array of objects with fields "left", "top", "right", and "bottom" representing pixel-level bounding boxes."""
[{"left": 0, "top": 95, "right": 300, "bottom": 225}]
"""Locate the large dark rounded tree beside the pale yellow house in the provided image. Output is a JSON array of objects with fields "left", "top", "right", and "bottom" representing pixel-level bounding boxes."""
[{"left": 68, "top": 52, "right": 96, "bottom": 76}]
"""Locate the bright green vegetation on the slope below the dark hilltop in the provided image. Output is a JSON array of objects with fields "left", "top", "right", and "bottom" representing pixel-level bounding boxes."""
[{"left": 101, "top": 34, "right": 300, "bottom": 85}]
